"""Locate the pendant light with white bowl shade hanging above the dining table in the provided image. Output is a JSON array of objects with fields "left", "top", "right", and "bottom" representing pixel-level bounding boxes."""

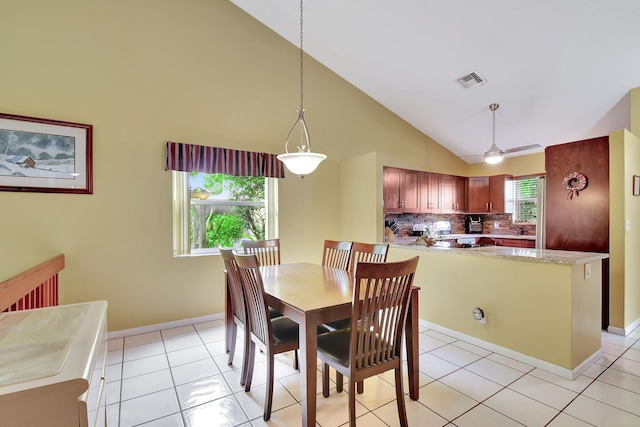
[{"left": 278, "top": 0, "right": 327, "bottom": 179}]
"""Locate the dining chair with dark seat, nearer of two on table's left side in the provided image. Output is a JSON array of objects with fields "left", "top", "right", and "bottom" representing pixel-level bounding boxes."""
[{"left": 235, "top": 254, "right": 299, "bottom": 421}]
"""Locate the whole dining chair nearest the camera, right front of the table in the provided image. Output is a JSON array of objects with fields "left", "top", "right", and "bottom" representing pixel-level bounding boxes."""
[{"left": 318, "top": 257, "right": 419, "bottom": 427}]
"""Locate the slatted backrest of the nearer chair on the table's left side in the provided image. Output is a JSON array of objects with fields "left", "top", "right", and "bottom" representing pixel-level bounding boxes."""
[{"left": 235, "top": 254, "right": 271, "bottom": 346}]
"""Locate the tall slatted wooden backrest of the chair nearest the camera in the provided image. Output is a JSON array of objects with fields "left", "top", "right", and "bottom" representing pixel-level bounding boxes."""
[{"left": 351, "top": 257, "right": 419, "bottom": 370}]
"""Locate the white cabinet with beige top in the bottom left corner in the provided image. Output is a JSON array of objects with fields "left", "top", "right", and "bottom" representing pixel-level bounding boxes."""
[{"left": 0, "top": 301, "right": 107, "bottom": 427}]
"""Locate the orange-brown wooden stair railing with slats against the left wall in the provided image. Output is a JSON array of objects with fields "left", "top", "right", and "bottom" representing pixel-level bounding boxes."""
[{"left": 0, "top": 254, "right": 64, "bottom": 313}]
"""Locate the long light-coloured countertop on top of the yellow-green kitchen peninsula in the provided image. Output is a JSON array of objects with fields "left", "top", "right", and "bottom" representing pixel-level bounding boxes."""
[{"left": 389, "top": 239, "right": 609, "bottom": 264}]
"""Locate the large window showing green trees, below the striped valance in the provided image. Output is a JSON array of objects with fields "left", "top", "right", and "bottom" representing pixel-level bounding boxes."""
[{"left": 172, "top": 171, "right": 277, "bottom": 256}]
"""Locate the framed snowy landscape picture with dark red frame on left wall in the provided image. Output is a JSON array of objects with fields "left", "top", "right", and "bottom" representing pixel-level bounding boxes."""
[{"left": 0, "top": 113, "right": 93, "bottom": 194}]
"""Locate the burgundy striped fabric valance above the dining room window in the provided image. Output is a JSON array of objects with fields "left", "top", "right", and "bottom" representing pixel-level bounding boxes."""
[{"left": 165, "top": 141, "right": 284, "bottom": 178}]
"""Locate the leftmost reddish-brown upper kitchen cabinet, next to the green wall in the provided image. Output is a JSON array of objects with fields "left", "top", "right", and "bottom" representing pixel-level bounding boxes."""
[{"left": 383, "top": 167, "right": 421, "bottom": 213}]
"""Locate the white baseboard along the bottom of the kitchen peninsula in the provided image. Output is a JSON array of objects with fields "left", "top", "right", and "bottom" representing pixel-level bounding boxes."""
[{"left": 420, "top": 319, "right": 603, "bottom": 381}]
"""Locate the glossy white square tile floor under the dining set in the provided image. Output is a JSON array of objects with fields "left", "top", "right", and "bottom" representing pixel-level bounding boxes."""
[{"left": 106, "top": 320, "right": 640, "bottom": 427}]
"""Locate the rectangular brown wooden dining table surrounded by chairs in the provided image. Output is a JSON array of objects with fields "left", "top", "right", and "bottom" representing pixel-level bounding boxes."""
[{"left": 225, "top": 262, "right": 420, "bottom": 427}]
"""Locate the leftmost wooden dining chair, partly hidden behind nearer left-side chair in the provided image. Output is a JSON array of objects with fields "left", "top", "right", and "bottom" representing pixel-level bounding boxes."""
[{"left": 220, "top": 248, "right": 249, "bottom": 385}]
